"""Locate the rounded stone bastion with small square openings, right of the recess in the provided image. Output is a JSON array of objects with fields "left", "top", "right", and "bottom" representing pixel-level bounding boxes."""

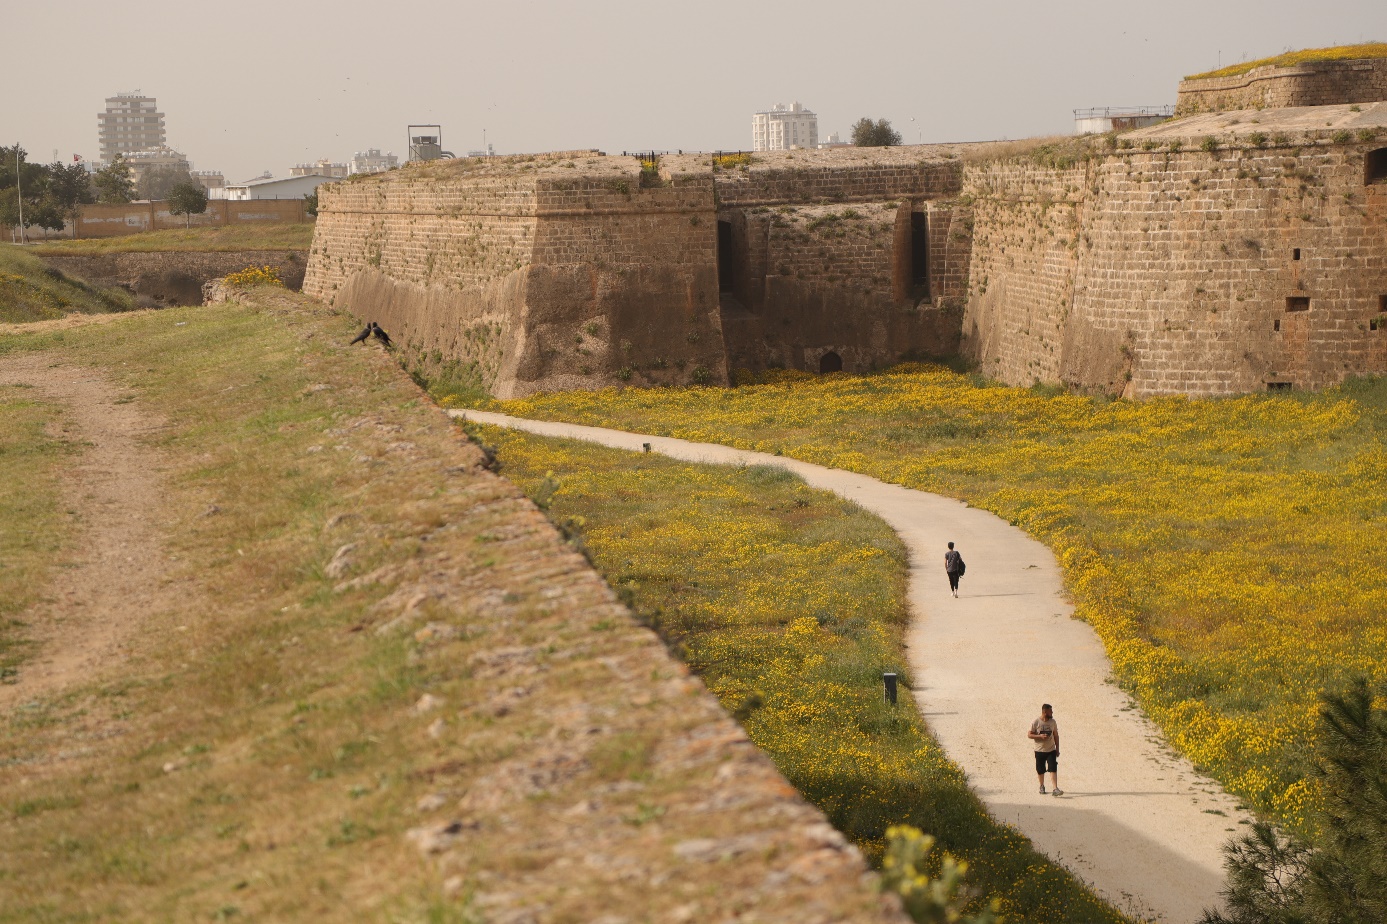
[{"left": 964, "top": 103, "right": 1387, "bottom": 395}]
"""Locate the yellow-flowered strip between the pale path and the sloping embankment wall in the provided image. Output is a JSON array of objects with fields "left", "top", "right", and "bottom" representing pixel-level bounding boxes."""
[{"left": 473, "top": 427, "right": 1123, "bottom": 923}]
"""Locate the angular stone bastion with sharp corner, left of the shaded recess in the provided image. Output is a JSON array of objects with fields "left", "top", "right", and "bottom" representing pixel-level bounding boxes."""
[{"left": 305, "top": 153, "right": 727, "bottom": 397}]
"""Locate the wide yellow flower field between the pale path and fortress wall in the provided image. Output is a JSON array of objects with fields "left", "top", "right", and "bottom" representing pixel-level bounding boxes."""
[{"left": 498, "top": 365, "right": 1387, "bottom": 835}]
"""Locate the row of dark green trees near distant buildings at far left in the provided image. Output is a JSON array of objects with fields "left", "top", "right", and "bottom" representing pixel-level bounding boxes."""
[{"left": 0, "top": 144, "right": 207, "bottom": 233}]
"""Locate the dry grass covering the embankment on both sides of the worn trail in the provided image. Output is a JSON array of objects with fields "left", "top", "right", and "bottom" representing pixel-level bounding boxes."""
[{"left": 0, "top": 294, "right": 574, "bottom": 924}]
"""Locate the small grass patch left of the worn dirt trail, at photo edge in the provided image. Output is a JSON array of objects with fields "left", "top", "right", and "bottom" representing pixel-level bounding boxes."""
[{"left": 0, "top": 386, "right": 74, "bottom": 683}]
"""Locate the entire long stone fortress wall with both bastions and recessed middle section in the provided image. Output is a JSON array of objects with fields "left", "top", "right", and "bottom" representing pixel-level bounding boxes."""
[{"left": 304, "top": 51, "right": 1387, "bottom": 397}]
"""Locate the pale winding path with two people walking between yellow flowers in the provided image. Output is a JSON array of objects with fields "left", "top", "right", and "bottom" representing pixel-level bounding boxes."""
[{"left": 452, "top": 411, "right": 1246, "bottom": 924}]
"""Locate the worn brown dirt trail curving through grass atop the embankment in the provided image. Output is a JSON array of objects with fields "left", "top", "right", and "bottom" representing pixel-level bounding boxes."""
[{"left": 0, "top": 352, "right": 186, "bottom": 710}]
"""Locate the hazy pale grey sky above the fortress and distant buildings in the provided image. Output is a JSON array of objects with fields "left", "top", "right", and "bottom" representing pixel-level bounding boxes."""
[{"left": 8, "top": 0, "right": 1387, "bottom": 182}]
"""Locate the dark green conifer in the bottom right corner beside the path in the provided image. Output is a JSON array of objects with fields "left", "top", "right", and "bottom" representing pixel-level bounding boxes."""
[{"left": 1204, "top": 680, "right": 1387, "bottom": 924}]
